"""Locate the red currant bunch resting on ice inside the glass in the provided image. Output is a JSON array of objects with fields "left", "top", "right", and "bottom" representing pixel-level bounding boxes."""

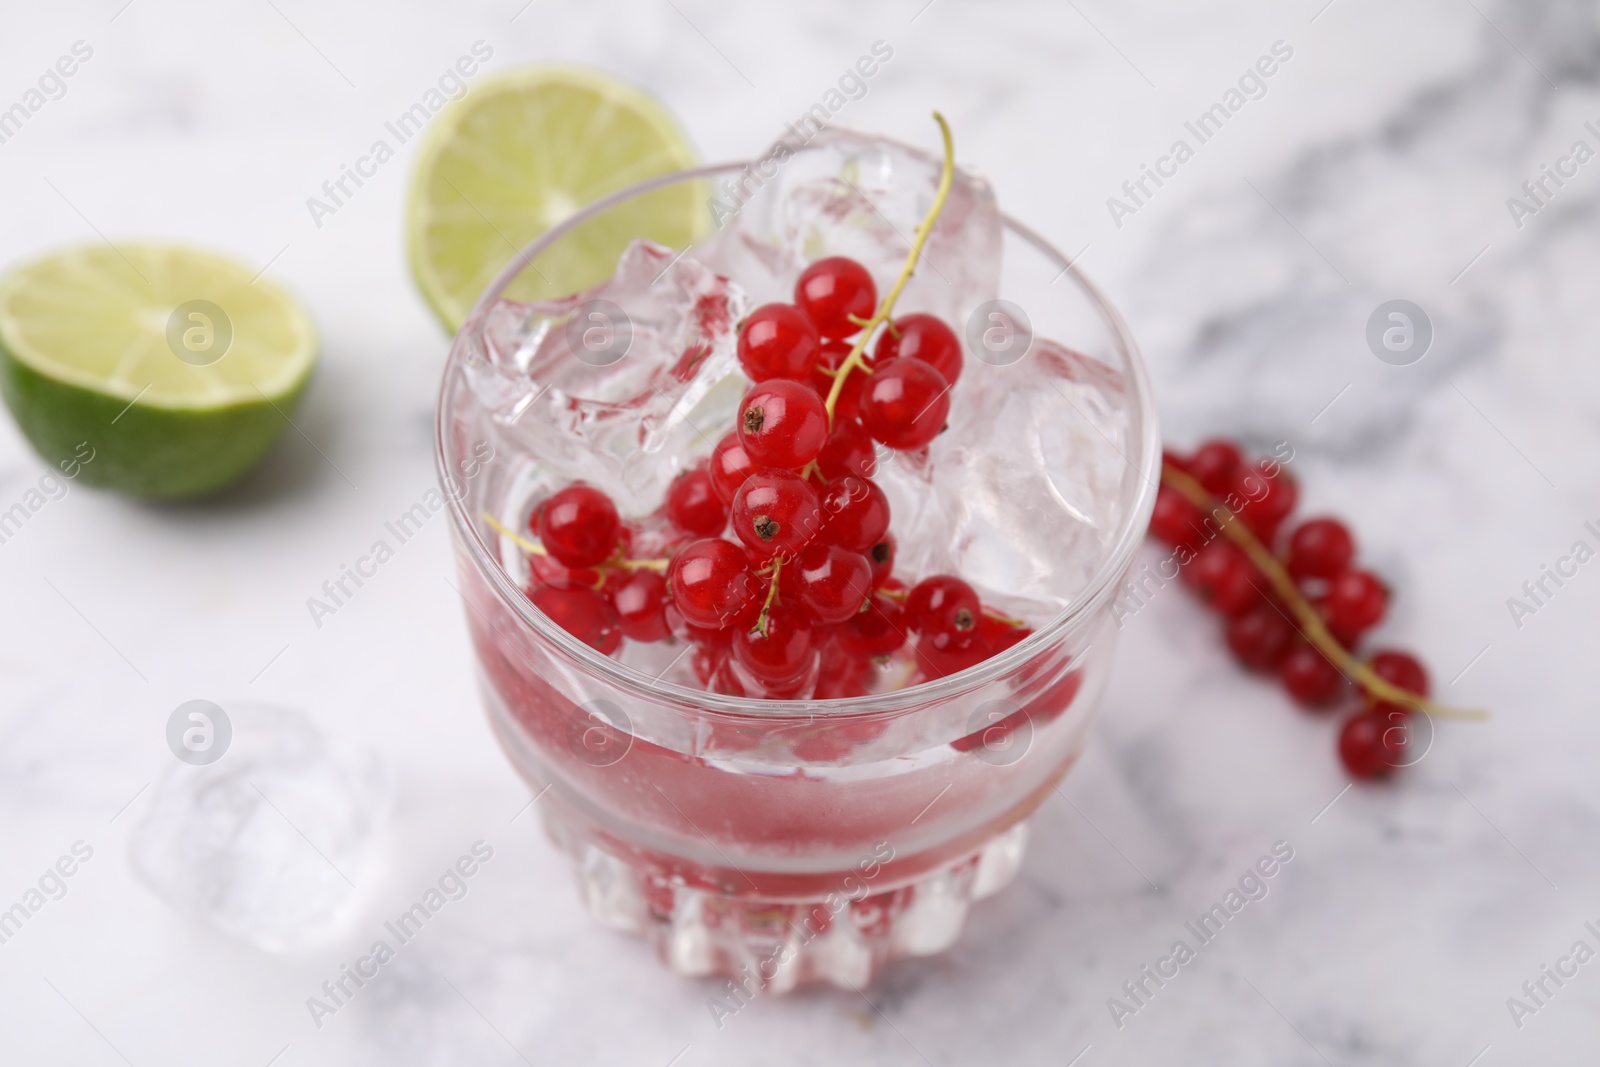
[{"left": 525, "top": 258, "right": 1030, "bottom": 699}]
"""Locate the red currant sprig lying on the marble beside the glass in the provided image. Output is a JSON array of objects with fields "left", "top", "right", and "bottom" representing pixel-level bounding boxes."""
[{"left": 1150, "top": 440, "right": 1429, "bottom": 777}]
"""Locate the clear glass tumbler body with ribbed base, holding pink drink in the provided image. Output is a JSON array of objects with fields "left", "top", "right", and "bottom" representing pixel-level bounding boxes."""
[{"left": 438, "top": 139, "right": 1160, "bottom": 990}]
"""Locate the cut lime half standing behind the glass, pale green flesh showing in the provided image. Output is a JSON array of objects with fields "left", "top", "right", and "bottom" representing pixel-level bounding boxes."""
[{"left": 406, "top": 66, "right": 710, "bottom": 333}]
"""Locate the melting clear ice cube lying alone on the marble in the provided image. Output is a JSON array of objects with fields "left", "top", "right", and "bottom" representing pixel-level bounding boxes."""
[{"left": 130, "top": 709, "right": 389, "bottom": 952}]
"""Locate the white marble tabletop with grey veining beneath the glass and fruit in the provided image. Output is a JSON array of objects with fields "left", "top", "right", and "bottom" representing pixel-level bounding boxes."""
[{"left": 0, "top": 0, "right": 1600, "bottom": 1067}]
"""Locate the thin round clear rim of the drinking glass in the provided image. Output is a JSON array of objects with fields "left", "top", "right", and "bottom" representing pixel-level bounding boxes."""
[{"left": 434, "top": 146, "right": 1162, "bottom": 718}]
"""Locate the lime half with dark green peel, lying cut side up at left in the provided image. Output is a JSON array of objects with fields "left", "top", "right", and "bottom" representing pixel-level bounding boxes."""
[{"left": 0, "top": 245, "right": 317, "bottom": 498}]
